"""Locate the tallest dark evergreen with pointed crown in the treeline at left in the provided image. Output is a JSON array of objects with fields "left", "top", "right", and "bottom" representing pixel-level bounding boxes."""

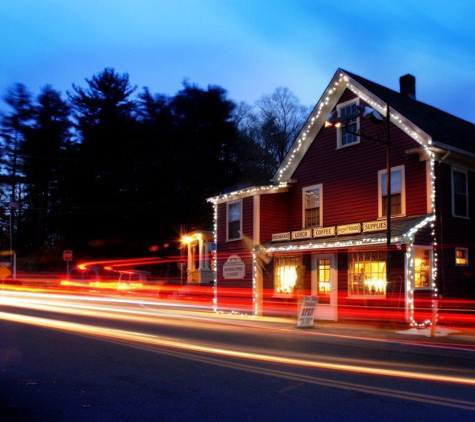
[{"left": 68, "top": 68, "right": 140, "bottom": 256}]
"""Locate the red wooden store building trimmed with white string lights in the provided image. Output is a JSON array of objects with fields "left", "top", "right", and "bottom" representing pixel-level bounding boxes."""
[{"left": 209, "top": 69, "right": 475, "bottom": 326}]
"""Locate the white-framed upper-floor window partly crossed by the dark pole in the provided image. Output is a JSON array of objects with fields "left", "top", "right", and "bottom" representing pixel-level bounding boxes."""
[{"left": 378, "top": 166, "right": 406, "bottom": 217}]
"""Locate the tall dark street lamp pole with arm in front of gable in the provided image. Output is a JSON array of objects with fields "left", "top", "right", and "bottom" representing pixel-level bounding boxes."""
[{"left": 325, "top": 104, "right": 391, "bottom": 283}]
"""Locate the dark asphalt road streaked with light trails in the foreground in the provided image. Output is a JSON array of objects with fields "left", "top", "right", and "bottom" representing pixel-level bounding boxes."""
[{"left": 0, "top": 296, "right": 475, "bottom": 422}]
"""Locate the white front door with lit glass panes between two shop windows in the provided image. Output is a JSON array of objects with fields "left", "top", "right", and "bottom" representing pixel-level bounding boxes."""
[{"left": 312, "top": 254, "right": 338, "bottom": 321}]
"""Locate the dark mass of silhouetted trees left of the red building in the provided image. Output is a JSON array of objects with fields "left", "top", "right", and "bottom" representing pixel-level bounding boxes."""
[{"left": 0, "top": 68, "right": 308, "bottom": 269}]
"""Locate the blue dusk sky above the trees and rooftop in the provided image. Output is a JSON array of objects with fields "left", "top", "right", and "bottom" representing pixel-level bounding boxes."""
[{"left": 0, "top": 0, "right": 475, "bottom": 122}]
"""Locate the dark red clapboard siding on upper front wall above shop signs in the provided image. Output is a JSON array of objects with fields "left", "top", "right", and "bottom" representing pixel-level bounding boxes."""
[{"left": 289, "top": 90, "right": 427, "bottom": 230}]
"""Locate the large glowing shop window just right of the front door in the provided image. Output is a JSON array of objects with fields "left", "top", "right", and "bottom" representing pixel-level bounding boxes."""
[{"left": 348, "top": 251, "right": 386, "bottom": 296}]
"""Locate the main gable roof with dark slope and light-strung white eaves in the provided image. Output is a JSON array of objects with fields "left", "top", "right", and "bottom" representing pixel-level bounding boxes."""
[{"left": 273, "top": 69, "right": 475, "bottom": 183}]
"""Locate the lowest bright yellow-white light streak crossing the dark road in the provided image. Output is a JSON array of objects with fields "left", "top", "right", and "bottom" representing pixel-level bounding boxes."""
[{"left": 0, "top": 304, "right": 475, "bottom": 386}]
